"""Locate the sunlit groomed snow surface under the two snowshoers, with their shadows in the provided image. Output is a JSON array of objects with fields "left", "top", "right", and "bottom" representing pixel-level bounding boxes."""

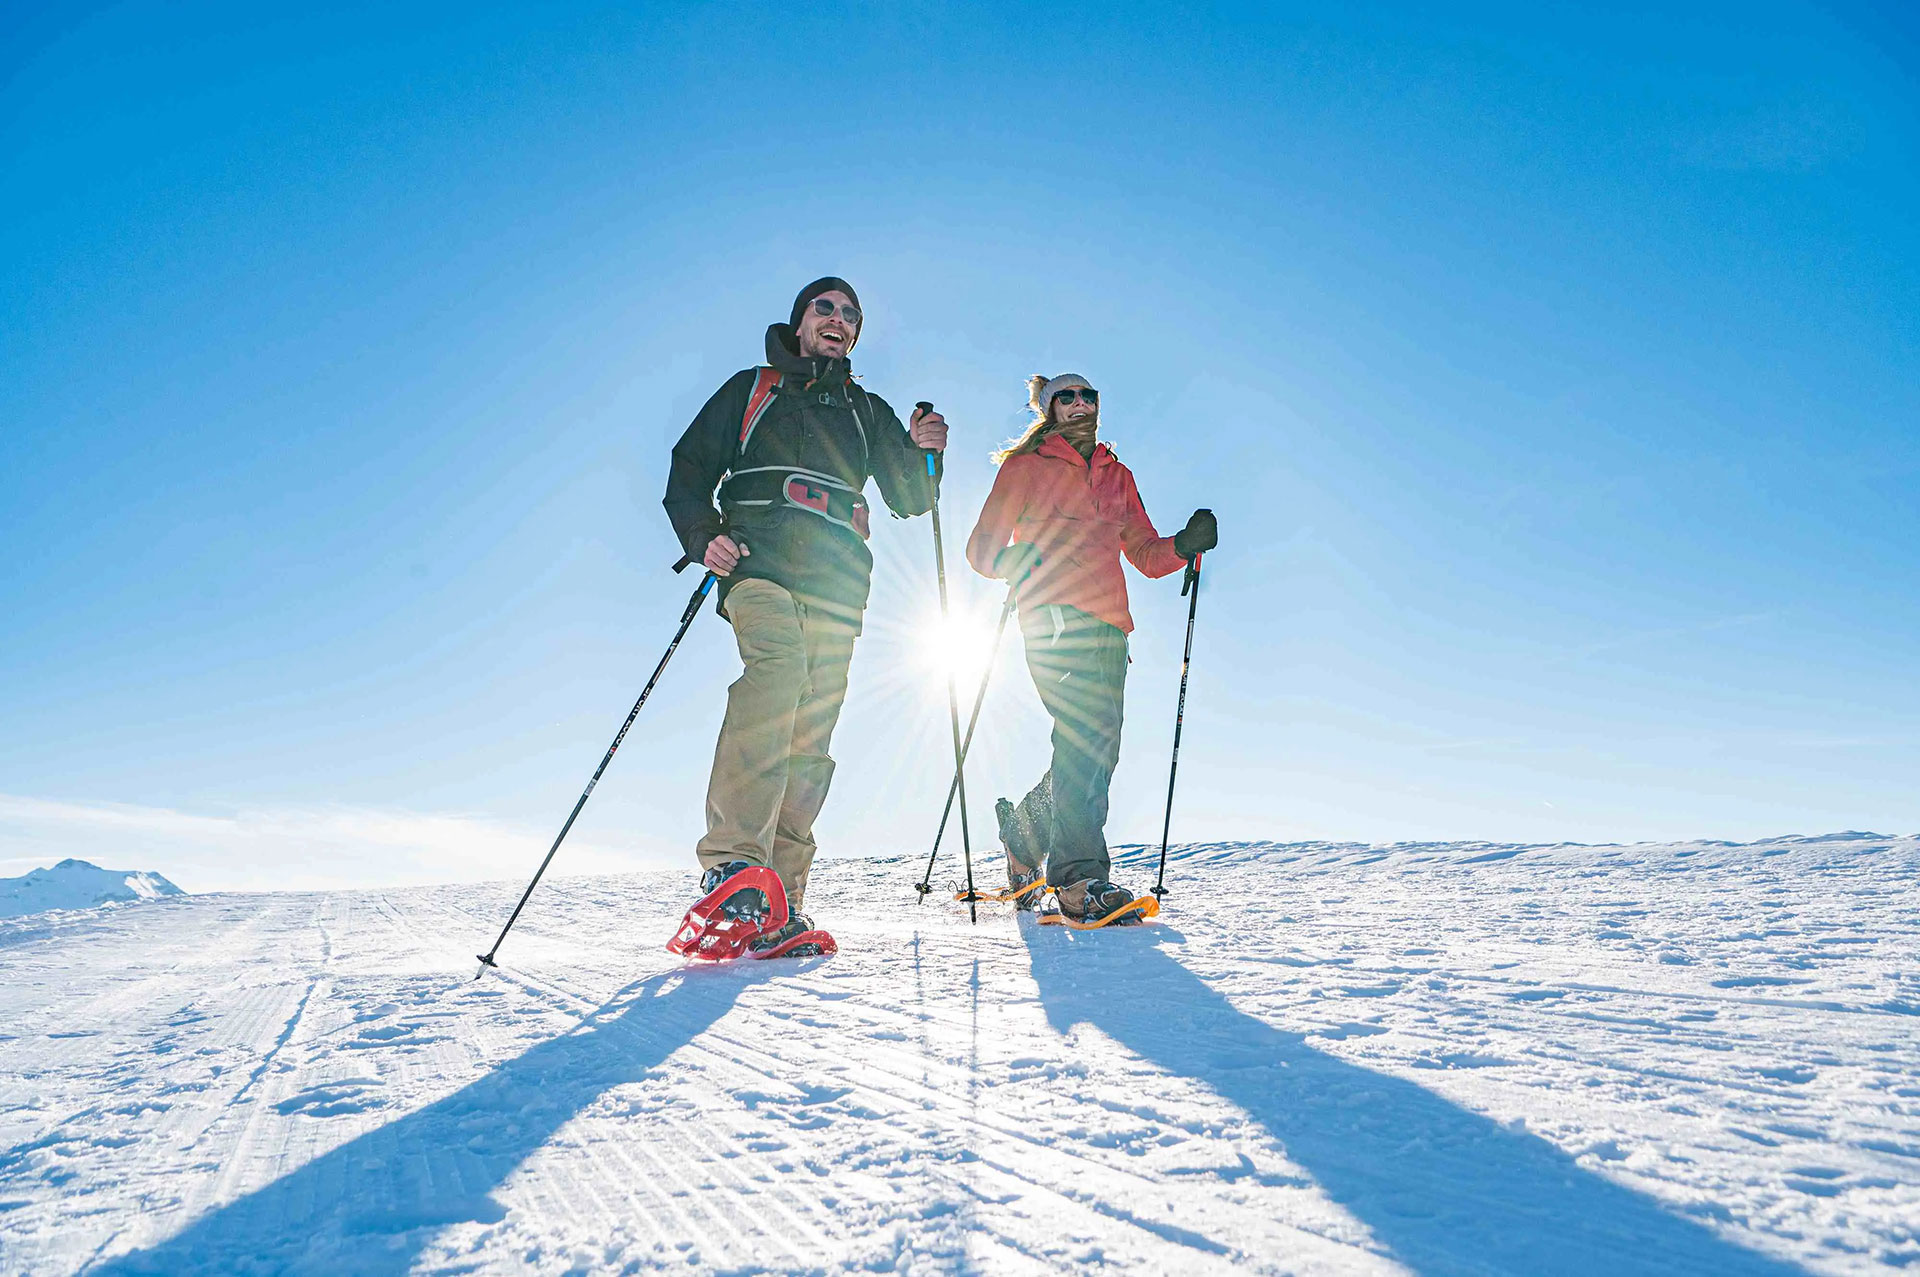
[{"left": 0, "top": 835, "right": 1920, "bottom": 1275}]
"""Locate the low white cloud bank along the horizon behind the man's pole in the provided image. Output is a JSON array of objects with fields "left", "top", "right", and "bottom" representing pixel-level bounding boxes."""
[{"left": 0, "top": 793, "right": 685, "bottom": 891}]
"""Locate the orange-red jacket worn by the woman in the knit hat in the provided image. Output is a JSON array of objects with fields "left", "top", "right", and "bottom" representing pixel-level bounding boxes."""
[{"left": 966, "top": 434, "right": 1187, "bottom": 632}]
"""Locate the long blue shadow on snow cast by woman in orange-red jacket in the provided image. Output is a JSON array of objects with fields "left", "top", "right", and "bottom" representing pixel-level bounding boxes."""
[{"left": 1021, "top": 916, "right": 1803, "bottom": 1277}]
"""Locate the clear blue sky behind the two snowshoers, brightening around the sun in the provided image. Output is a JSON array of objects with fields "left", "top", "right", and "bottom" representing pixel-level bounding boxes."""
[{"left": 0, "top": 4, "right": 1920, "bottom": 889}]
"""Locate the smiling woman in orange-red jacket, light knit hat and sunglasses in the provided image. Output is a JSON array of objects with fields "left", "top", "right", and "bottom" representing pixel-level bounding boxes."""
[{"left": 966, "top": 373, "right": 1219, "bottom": 922}]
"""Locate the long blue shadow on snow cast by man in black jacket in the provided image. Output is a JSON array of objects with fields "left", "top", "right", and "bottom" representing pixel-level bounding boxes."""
[{"left": 90, "top": 964, "right": 771, "bottom": 1275}]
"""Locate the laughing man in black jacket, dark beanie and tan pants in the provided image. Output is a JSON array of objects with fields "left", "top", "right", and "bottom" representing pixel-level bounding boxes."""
[{"left": 664, "top": 277, "right": 947, "bottom": 952}]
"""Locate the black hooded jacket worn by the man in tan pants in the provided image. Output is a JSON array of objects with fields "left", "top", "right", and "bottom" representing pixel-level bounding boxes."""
[{"left": 664, "top": 325, "right": 933, "bottom": 628}]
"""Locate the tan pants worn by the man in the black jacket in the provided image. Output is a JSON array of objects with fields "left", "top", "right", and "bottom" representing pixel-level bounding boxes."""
[{"left": 697, "top": 578, "right": 854, "bottom": 908}]
